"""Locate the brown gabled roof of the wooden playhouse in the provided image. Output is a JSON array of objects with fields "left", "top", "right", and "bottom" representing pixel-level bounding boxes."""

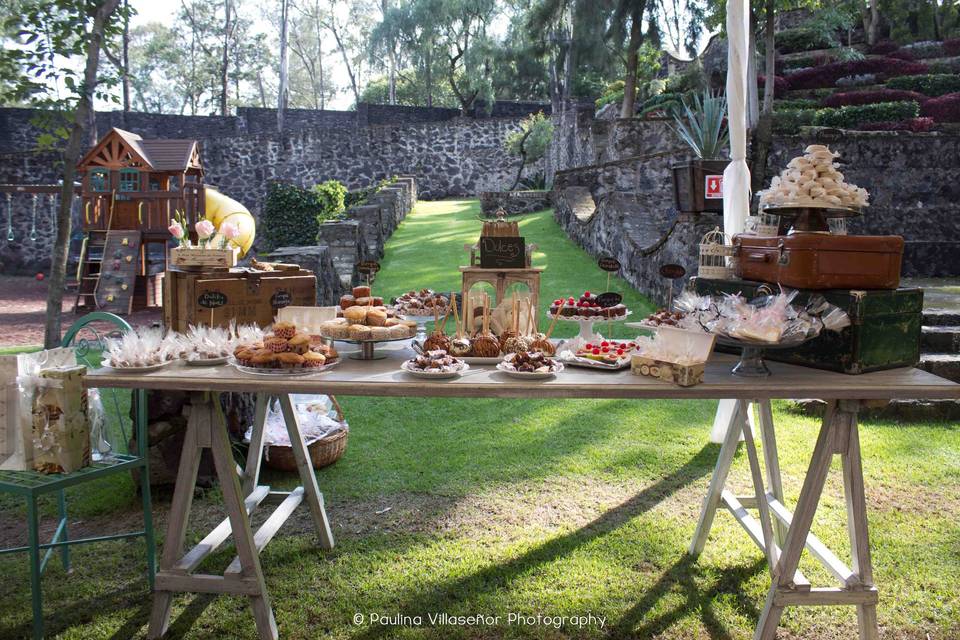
[{"left": 79, "top": 127, "right": 201, "bottom": 171}]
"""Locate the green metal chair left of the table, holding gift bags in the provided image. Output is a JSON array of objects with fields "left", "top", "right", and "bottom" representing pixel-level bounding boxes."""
[{"left": 0, "top": 311, "right": 156, "bottom": 639}]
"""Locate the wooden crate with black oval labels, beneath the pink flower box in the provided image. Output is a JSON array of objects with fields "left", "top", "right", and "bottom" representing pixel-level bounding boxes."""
[{"left": 163, "top": 269, "right": 317, "bottom": 331}]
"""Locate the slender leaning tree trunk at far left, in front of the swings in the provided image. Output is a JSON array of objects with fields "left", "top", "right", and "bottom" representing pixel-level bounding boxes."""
[{"left": 43, "top": 0, "right": 120, "bottom": 349}]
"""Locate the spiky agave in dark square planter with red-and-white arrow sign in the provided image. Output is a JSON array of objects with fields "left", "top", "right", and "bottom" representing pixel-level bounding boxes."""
[{"left": 670, "top": 90, "right": 730, "bottom": 213}]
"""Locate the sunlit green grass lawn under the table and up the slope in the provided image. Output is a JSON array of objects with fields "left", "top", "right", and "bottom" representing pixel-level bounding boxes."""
[{"left": 0, "top": 201, "right": 960, "bottom": 640}]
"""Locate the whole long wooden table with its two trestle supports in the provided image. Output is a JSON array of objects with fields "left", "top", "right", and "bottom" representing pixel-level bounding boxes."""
[{"left": 87, "top": 343, "right": 960, "bottom": 640}]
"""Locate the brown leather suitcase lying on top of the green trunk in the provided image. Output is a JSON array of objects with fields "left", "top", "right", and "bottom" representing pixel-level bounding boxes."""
[{"left": 733, "top": 233, "right": 903, "bottom": 289}]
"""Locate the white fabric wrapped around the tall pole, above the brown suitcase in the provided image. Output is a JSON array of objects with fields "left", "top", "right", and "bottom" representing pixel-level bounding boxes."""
[{"left": 723, "top": 0, "right": 750, "bottom": 237}]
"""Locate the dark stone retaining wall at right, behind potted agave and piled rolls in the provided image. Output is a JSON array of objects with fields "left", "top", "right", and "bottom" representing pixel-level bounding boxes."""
[{"left": 550, "top": 108, "right": 960, "bottom": 301}]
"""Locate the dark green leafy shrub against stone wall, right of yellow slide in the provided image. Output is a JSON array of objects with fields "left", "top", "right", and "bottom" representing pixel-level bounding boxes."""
[{"left": 257, "top": 180, "right": 346, "bottom": 251}]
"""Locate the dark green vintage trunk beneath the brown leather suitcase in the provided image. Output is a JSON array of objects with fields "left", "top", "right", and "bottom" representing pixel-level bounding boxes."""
[{"left": 688, "top": 278, "right": 923, "bottom": 374}]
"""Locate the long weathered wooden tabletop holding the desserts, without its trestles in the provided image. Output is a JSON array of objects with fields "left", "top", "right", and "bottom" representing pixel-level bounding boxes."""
[{"left": 86, "top": 342, "right": 960, "bottom": 400}]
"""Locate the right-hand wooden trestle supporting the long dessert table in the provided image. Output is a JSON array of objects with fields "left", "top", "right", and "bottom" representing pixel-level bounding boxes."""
[{"left": 690, "top": 400, "right": 879, "bottom": 640}]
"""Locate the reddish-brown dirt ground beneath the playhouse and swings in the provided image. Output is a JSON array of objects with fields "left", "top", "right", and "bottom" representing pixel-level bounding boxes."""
[{"left": 0, "top": 276, "right": 161, "bottom": 347}]
